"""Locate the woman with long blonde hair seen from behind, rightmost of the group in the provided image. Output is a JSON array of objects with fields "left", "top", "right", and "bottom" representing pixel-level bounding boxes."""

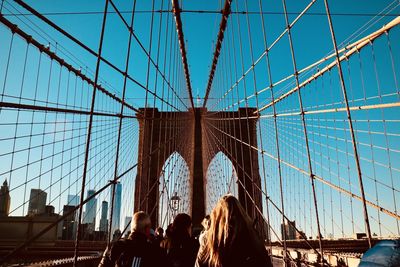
[{"left": 196, "top": 195, "right": 272, "bottom": 267}]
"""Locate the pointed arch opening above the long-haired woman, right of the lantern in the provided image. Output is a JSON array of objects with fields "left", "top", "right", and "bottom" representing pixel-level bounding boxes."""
[{"left": 205, "top": 152, "right": 239, "bottom": 214}]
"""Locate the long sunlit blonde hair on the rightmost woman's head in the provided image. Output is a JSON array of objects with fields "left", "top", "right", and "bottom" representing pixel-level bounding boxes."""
[{"left": 205, "top": 195, "right": 260, "bottom": 266}]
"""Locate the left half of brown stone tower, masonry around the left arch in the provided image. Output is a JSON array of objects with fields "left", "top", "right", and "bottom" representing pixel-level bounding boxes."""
[{"left": 134, "top": 108, "right": 193, "bottom": 224}]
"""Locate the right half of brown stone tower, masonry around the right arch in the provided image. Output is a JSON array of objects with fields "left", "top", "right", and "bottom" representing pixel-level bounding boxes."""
[{"left": 203, "top": 108, "right": 262, "bottom": 221}]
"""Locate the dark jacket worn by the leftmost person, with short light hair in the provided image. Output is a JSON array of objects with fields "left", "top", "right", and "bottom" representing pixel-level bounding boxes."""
[{"left": 99, "top": 232, "right": 166, "bottom": 267}]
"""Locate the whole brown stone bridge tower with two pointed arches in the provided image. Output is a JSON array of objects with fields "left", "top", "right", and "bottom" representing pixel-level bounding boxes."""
[{"left": 135, "top": 108, "right": 262, "bottom": 233}]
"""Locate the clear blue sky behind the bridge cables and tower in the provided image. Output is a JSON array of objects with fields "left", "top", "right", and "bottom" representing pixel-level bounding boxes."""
[{"left": 0, "top": 0, "right": 400, "bottom": 241}]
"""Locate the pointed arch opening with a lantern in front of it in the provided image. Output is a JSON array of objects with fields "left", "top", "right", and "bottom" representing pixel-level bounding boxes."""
[{"left": 158, "top": 151, "right": 190, "bottom": 229}]
